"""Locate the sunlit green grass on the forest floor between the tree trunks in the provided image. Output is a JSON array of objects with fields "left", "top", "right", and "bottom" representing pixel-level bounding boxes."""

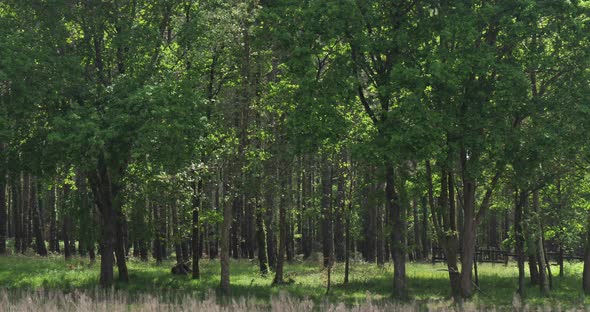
[{"left": 0, "top": 256, "right": 590, "bottom": 309}]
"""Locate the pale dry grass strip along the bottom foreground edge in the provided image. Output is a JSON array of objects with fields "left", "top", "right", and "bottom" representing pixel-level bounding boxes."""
[{"left": 0, "top": 291, "right": 588, "bottom": 312}]
